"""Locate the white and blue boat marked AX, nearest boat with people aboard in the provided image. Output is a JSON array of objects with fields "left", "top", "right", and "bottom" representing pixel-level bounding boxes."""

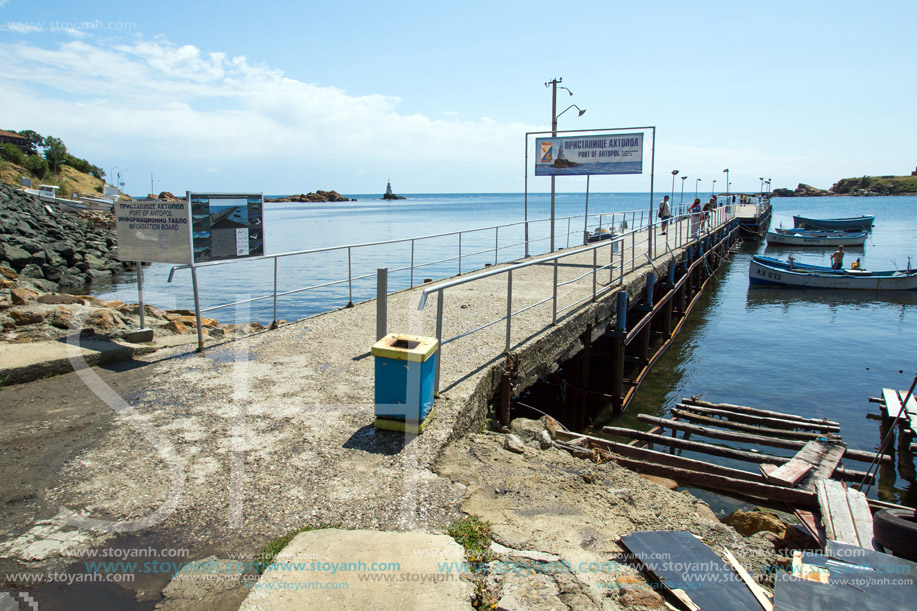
[{"left": 748, "top": 256, "right": 917, "bottom": 291}]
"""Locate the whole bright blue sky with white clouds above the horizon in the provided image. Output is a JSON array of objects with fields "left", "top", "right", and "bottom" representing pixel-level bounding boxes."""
[{"left": 0, "top": 0, "right": 917, "bottom": 195}]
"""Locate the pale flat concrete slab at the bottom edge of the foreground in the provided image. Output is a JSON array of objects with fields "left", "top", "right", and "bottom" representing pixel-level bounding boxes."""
[{"left": 240, "top": 529, "right": 473, "bottom": 611}]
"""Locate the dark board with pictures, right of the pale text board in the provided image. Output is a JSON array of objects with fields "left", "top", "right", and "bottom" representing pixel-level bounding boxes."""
[{"left": 188, "top": 192, "right": 264, "bottom": 263}]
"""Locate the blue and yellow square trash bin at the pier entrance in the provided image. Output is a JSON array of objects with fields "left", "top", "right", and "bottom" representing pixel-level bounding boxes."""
[{"left": 372, "top": 333, "right": 439, "bottom": 434}]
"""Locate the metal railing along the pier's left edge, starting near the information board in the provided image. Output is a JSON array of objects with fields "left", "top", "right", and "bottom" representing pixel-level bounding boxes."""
[{"left": 168, "top": 210, "right": 664, "bottom": 321}]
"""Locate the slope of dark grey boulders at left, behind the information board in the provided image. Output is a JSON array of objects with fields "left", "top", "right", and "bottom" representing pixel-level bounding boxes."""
[{"left": 0, "top": 185, "right": 129, "bottom": 291}]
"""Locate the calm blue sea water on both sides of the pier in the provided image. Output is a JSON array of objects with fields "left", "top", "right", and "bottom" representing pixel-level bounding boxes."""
[{"left": 94, "top": 192, "right": 917, "bottom": 505}]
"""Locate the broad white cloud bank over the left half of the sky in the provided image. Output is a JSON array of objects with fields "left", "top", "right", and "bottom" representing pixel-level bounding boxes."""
[{"left": 0, "top": 37, "right": 532, "bottom": 192}]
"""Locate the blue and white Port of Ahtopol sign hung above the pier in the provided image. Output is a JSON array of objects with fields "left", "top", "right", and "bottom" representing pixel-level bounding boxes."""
[{"left": 535, "top": 133, "right": 643, "bottom": 176}]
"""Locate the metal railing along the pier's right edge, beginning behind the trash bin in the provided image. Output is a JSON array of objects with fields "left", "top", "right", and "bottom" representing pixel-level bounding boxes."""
[{"left": 417, "top": 207, "right": 735, "bottom": 393}]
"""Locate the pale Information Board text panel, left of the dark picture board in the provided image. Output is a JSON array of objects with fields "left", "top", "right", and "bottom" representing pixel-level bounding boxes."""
[{"left": 114, "top": 201, "right": 191, "bottom": 264}]
